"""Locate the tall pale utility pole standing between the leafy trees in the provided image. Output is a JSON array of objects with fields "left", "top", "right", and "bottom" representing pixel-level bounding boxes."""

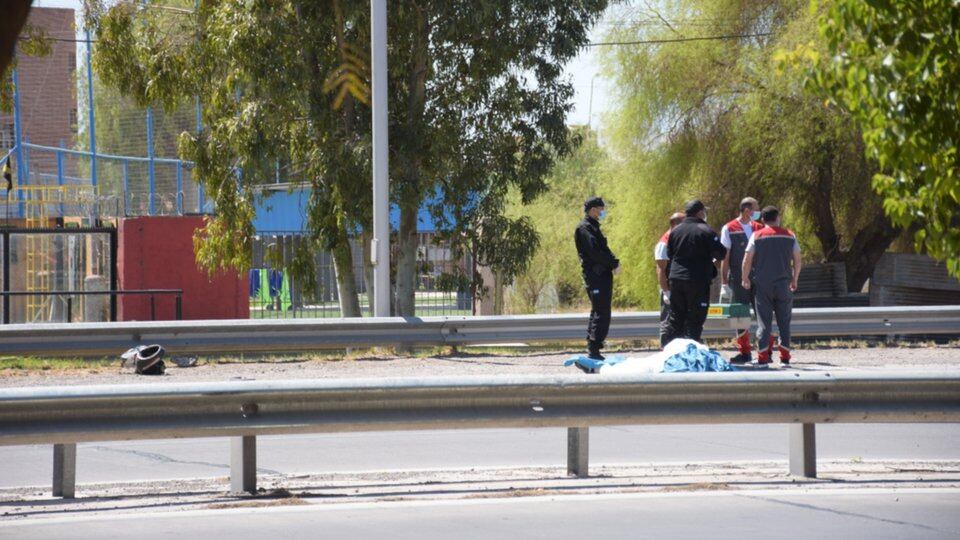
[{"left": 370, "top": 0, "right": 390, "bottom": 317}]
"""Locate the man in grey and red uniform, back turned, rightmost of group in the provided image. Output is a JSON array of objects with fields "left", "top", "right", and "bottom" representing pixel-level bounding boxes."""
[{"left": 741, "top": 206, "right": 801, "bottom": 365}]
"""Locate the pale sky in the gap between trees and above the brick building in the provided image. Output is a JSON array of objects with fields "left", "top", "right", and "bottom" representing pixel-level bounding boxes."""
[{"left": 33, "top": 0, "right": 610, "bottom": 129}]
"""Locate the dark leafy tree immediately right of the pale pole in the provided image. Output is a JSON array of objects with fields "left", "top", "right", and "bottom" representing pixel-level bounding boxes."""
[{"left": 378, "top": 0, "right": 607, "bottom": 315}]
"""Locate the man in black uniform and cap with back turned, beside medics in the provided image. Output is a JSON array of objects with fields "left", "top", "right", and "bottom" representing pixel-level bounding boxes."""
[{"left": 663, "top": 200, "right": 727, "bottom": 343}]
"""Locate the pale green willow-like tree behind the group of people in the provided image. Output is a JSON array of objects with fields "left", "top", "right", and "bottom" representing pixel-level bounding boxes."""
[{"left": 608, "top": 0, "right": 900, "bottom": 307}]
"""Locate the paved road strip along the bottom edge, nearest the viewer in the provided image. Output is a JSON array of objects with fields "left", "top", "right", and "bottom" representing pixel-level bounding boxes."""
[{"left": 0, "top": 489, "right": 960, "bottom": 540}]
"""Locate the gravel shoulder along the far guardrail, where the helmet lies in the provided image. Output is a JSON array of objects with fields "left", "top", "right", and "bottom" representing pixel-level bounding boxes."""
[{"left": 0, "top": 344, "right": 960, "bottom": 388}]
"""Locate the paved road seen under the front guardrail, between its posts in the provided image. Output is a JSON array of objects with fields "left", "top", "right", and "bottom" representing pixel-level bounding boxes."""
[{"left": 0, "top": 424, "right": 960, "bottom": 487}]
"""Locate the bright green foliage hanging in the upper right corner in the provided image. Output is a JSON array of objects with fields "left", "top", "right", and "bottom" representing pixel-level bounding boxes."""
[{"left": 811, "top": 0, "right": 960, "bottom": 277}]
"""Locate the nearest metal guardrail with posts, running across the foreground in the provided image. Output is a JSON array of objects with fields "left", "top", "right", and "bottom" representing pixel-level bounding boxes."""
[{"left": 0, "top": 371, "right": 960, "bottom": 497}]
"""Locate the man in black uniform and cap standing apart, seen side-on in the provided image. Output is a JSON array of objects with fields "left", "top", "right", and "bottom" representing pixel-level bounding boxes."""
[{"left": 573, "top": 197, "right": 620, "bottom": 360}]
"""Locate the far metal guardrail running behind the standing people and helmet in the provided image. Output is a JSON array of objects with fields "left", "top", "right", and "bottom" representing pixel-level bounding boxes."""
[{"left": 0, "top": 306, "right": 960, "bottom": 356}]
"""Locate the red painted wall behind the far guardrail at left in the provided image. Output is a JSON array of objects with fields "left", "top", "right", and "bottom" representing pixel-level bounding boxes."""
[{"left": 117, "top": 216, "right": 250, "bottom": 321}]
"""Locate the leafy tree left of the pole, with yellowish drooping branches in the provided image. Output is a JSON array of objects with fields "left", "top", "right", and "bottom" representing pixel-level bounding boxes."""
[{"left": 88, "top": 0, "right": 371, "bottom": 317}]
